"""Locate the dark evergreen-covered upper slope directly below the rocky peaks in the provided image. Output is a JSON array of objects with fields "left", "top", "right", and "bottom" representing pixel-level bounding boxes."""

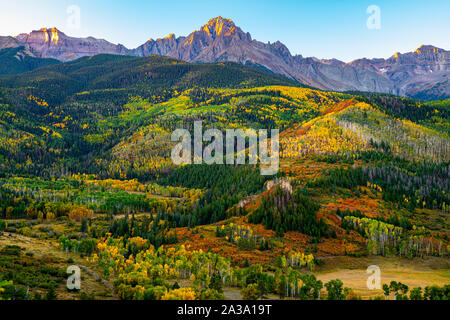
[{"left": 0, "top": 55, "right": 300, "bottom": 102}]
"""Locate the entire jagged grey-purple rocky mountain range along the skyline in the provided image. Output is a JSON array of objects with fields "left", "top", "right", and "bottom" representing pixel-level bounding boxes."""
[{"left": 0, "top": 17, "right": 450, "bottom": 99}]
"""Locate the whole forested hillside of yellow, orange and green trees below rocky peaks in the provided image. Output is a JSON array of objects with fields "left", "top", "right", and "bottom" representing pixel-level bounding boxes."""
[{"left": 0, "top": 55, "right": 450, "bottom": 299}]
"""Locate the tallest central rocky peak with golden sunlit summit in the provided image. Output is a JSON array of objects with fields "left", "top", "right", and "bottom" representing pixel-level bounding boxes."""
[{"left": 133, "top": 17, "right": 304, "bottom": 80}]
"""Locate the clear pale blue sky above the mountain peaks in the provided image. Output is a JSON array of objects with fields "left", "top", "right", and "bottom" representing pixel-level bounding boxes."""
[{"left": 0, "top": 0, "right": 450, "bottom": 62}]
